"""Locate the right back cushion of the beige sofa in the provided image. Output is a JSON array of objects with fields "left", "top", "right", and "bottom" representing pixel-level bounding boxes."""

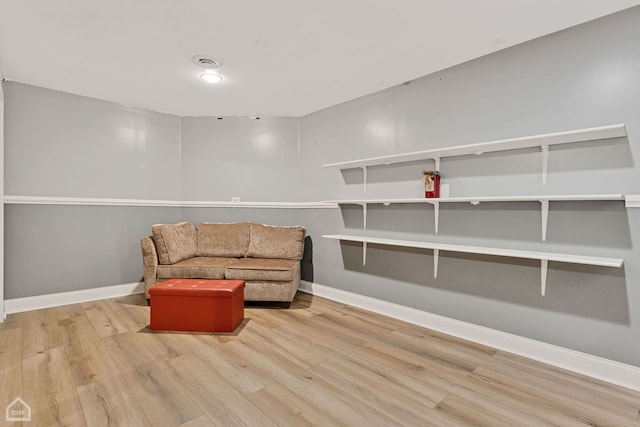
[{"left": 247, "top": 224, "right": 305, "bottom": 260}]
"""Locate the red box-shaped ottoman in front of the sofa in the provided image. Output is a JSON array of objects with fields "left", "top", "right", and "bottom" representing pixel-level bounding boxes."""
[{"left": 149, "top": 279, "right": 244, "bottom": 332}]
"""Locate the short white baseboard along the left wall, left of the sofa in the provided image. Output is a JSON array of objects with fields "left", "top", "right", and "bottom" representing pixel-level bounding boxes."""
[{"left": 4, "top": 282, "right": 144, "bottom": 314}]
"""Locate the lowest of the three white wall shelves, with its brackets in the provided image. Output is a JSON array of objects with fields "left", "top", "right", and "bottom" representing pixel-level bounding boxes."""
[{"left": 322, "top": 234, "right": 624, "bottom": 296}]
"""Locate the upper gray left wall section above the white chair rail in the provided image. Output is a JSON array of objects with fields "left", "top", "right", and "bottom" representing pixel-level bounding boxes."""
[{"left": 5, "top": 83, "right": 180, "bottom": 200}]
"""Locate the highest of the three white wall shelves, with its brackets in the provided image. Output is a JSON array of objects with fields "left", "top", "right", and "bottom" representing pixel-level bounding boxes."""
[{"left": 323, "top": 124, "right": 627, "bottom": 191}]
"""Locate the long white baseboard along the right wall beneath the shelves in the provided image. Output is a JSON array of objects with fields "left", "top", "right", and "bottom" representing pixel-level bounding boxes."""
[{"left": 299, "top": 281, "right": 640, "bottom": 391}]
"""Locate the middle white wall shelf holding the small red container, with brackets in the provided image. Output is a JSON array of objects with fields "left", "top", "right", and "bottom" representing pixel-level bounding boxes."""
[{"left": 325, "top": 194, "right": 625, "bottom": 242}]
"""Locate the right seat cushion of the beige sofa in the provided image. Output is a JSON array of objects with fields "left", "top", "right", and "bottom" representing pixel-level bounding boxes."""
[{"left": 224, "top": 258, "right": 300, "bottom": 282}]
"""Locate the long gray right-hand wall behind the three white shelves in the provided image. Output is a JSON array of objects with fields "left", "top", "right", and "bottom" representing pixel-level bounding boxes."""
[{"left": 300, "top": 7, "right": 640, "bottom": 366}]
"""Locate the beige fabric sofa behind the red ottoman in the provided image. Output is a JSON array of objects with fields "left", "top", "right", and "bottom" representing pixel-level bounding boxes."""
[{"left": 141, "top": 222, "right": 305, "bottom": 305}]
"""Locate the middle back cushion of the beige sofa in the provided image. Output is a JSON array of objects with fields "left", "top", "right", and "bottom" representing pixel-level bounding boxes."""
[{"left": 196, "top": 222, "right": 251, "bottom": 258}]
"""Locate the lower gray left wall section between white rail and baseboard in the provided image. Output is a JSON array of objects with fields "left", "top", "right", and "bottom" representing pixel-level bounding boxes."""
[{"left": 5, "top": 205, "right": 180, "bottom": 299}]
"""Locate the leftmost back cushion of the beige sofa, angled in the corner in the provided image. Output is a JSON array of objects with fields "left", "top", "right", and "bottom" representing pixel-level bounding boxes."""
[{"left": 151, "top": 222, "right": 196, "bottom": 265}]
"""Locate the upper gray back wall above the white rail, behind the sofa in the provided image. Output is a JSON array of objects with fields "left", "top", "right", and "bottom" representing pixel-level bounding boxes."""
[{"left": 181, "top": 117, "right": 302, "bottom": 201}]
